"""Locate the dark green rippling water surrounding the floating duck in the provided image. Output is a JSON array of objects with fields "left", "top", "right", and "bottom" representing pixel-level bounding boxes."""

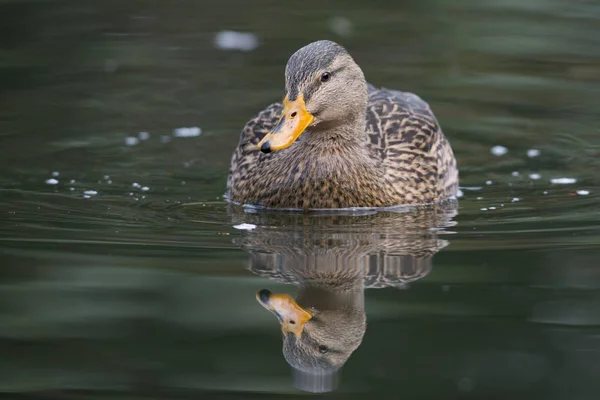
[{"left": 0, "top": 0, "right": 600, "bottom": 399}]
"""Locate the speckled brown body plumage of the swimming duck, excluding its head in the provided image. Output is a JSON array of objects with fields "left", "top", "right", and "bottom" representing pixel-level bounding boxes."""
[{"left": 227, "top": 40, "right": 458, "bottom": 209}]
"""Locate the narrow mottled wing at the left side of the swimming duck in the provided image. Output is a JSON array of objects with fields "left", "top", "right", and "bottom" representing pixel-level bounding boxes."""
[{"left": 227, "top": 102, "right": 283, "bottom": 199}]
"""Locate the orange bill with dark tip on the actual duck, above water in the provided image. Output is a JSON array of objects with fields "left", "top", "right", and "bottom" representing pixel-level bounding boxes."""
[{"left": 258, "top": 95, "right": 315, "bottom": 153}]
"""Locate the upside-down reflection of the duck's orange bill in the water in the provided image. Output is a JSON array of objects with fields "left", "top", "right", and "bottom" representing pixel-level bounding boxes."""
[{"left": 256, "top": 289, "right": 313, "bottom": 338}]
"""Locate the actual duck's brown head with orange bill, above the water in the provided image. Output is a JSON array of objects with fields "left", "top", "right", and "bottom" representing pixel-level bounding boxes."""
[{"left": 258, "top": 40, "right": 368, "bottom": 153}]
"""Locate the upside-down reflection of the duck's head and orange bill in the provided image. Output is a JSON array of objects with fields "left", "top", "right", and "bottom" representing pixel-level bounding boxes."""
[{"left": 256, "top": 289, "right": 366, "bottom": 392}]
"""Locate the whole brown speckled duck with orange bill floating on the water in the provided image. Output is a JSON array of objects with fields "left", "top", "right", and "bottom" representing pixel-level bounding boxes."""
[{"left": 227, "top": 40, "right": 458, "bottom": 209}]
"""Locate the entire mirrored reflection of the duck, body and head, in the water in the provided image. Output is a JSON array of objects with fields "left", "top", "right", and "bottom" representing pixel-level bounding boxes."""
[{"left": 234, "top": 205, "right": 456, "bottom": 392}]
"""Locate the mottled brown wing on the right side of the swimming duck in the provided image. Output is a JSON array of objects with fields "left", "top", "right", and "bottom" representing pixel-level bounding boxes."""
[{"left": 366, "top": 85, "right": 458, "bottom": 203}]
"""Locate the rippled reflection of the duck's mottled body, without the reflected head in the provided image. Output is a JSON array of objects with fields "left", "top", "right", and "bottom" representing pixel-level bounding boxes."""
[{"left": 233, "top": 206, "right": 457, "bottom": 288}]
